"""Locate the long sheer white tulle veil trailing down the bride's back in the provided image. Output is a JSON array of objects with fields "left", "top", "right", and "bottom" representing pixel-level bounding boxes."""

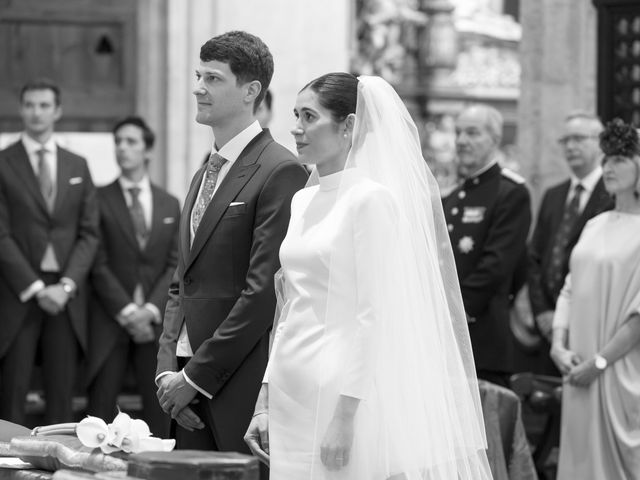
[{"left": 272, "top": 76, "right": 492, "bottom": 480}]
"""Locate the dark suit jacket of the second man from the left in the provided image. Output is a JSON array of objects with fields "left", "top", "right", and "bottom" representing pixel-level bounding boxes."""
[{"left": 88, "top": 180, "right": 180, "bottom": 381}]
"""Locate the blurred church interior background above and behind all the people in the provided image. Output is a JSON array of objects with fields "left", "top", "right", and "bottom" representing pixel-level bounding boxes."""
[{"left": 0, "top": 0, "right": 640, "bottom": 203}]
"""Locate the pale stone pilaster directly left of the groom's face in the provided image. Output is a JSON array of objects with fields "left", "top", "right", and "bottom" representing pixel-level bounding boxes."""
[{"left": 136, "top": 0, "right": 218, "bottom": 201}]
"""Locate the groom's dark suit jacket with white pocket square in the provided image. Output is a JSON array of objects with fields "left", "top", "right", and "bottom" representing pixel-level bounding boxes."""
[{"left": 157, "top": 130, "right": 307, "bottom": 452}]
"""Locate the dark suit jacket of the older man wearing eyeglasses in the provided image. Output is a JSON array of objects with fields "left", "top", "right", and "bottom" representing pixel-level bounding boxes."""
[{"left": 528, "top": 178, "right": 613, "bottom": 315}]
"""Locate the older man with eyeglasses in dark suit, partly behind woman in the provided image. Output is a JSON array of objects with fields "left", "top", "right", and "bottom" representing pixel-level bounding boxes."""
[{"left": 528, "top": 112, "right": 613, "bottom": 376}]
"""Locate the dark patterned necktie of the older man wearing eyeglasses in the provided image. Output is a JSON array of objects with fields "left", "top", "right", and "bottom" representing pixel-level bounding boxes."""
[{"left": 546, "top": 183, "right": 584, "bottom": 299}]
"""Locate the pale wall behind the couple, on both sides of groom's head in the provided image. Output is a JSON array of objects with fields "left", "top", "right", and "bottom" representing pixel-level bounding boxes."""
[{"left": 159, "top": 0, "right": 353, "bottom": 199}]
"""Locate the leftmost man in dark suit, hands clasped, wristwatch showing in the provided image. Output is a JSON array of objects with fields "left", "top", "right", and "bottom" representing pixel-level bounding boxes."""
[{"left": 0, "top": 80, "right": 98, "bottom": 424}]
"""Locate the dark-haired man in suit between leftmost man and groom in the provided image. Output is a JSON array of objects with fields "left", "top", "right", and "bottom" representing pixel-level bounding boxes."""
[{"left": 87, "top": 117, "right": 180, "bottom": 437}]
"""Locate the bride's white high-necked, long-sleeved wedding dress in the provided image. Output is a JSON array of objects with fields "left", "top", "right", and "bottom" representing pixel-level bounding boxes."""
[{"left": 267, "top": 170, "right": 393, "bottom": 480}]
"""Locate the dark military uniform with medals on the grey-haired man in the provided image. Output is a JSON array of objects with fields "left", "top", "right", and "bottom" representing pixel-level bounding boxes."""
[{"left": 444, "top": 164, "right": 531, "bottom": 372}]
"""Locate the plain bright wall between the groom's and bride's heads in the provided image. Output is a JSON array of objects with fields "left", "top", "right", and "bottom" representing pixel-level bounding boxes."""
[{"left": 216, "top": 0, "right": 352, "bottom": 151}]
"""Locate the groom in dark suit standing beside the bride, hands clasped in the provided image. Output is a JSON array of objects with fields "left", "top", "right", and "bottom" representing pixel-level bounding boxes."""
[{"left": 156, "top": 31, "right": 307, "bottom": 462}]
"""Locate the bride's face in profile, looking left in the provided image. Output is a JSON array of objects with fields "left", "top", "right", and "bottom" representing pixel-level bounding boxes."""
[{"left": 291, "top": 88, "right": 349, "bottom": 175}]
